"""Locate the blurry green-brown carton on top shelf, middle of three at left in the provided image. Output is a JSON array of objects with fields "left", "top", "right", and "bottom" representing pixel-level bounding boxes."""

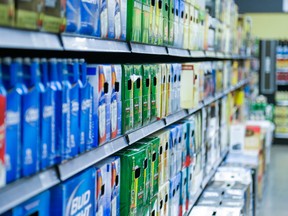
[{"left": 16, "top": 0, "right": 42, "bottom": 30}]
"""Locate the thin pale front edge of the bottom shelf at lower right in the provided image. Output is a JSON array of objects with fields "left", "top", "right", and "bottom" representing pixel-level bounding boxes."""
[{"left": 185, "top": 150, "right": 229, "bottom": 216}]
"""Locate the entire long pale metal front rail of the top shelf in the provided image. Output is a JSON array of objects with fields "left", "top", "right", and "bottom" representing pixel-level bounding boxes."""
[{"left": 0, "top": 27, "right": 251, "bottom": 59}]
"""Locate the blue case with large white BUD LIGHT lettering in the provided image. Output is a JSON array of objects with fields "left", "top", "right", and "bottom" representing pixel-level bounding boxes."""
[{"left": 50, "top": 168, "right": 96, "bottom": 216}]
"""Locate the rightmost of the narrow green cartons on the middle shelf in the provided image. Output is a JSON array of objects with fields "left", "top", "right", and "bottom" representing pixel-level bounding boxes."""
[{"left": 150, "top": 65, "right": 157, "bottom": 121}]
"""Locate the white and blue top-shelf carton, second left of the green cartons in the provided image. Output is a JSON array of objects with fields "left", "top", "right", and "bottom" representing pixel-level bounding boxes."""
[{"left": 100, "top": 0, "right": 115, "bottom": 39}]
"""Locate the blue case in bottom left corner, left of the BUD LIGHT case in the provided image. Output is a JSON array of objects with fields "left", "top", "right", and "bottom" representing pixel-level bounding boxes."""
[{"left": 4, "top": 191, "right": 50, "bottom": 216}]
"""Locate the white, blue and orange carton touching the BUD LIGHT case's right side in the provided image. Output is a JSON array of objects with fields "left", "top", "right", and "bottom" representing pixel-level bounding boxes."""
[{"left": 95, "top": 160, "right": 111, "bottom": 216}]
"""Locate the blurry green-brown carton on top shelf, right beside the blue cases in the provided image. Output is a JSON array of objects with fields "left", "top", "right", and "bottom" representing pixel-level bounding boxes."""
[{"left": 40, "top": 0, "right": 66, "bottom": 33}]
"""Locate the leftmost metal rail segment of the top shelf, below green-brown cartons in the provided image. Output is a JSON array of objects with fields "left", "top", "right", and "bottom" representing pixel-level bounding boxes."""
[{"left": 0, "top": 27, "right": 63, "bottom": 51}]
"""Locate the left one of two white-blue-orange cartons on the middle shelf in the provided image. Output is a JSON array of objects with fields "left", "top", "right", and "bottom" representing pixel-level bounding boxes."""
[{"left": 98, "top": 65, "right": 112, "bottom": 145}]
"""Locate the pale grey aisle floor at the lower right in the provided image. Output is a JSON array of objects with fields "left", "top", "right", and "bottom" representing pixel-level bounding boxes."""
[{"left": 258, "top": 145, "right": 288, "bottom": 216}]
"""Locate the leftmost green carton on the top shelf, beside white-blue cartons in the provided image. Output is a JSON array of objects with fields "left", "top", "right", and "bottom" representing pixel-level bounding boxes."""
[{"left": 127, "top": 0, "right": 142, "bottom": 42}]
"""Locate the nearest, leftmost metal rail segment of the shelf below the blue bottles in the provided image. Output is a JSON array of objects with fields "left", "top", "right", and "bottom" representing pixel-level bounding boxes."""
[{"left": 0, "top": 168, "right": 60, "bottom": 214}]
